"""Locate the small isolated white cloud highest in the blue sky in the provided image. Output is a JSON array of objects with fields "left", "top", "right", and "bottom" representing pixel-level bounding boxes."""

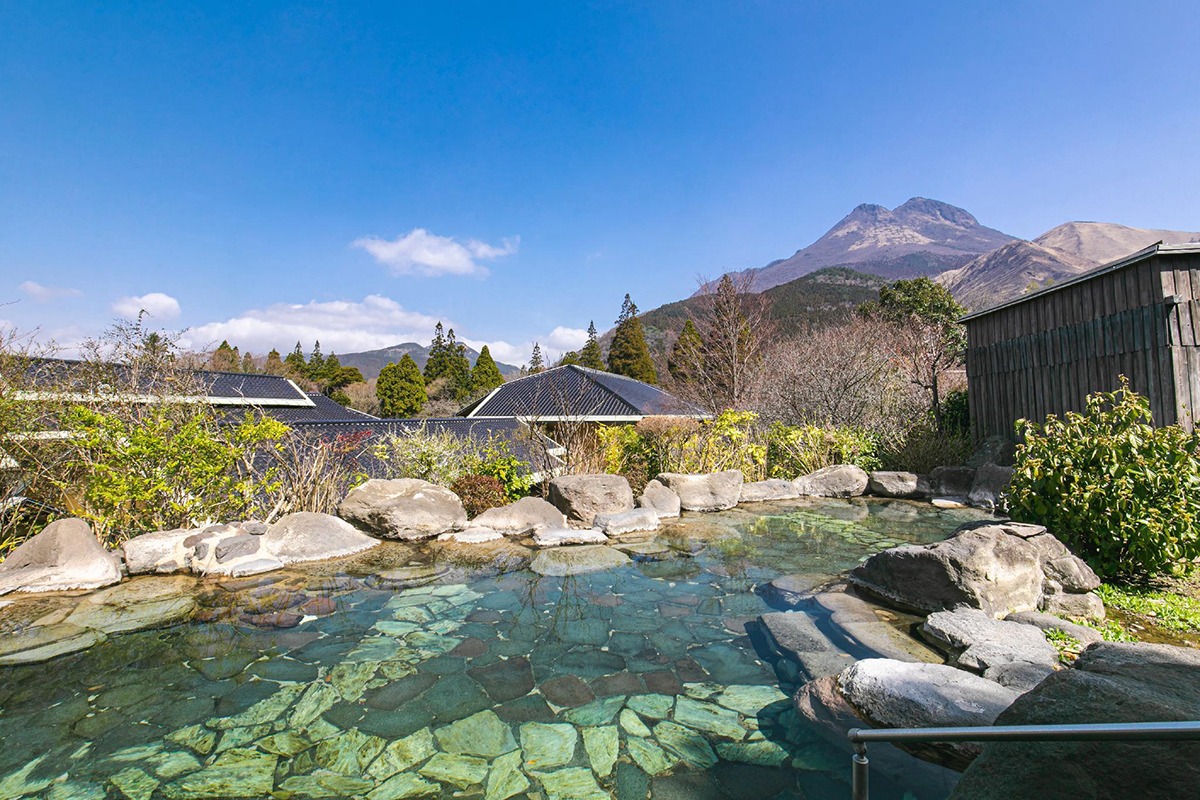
[{"left": 350, "top": 228, "right": 521, "bottom": 277}]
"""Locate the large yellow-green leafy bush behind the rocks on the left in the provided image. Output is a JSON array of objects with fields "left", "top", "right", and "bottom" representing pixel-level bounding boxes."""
[{"left": 60, "top": 403, "right": 288, "bottom": 542}]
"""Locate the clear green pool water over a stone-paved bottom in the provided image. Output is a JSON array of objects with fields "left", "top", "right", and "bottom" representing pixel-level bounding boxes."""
[{"left": 0, "top": 500, "right": 993, "bottom": 800}]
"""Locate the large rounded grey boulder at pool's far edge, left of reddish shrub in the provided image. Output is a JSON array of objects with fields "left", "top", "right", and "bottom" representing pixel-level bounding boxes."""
[{"left": 337, "top": 477, "right": 467, "bottom": 541}]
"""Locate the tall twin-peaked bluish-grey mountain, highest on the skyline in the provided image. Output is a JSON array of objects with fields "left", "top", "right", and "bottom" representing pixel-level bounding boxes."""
[{"left": 705, "top": 197, "right": 1014, "bottom": 291}]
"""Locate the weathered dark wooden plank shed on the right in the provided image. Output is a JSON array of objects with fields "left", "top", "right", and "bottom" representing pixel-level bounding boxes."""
[{"left": 962, "top": 242, "right": 1200, "bottom": 439}]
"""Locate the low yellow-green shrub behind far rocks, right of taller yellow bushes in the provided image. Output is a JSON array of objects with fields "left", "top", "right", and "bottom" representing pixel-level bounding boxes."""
[{"left": 767, "top": 422, "right": 880, "bottom": 480}]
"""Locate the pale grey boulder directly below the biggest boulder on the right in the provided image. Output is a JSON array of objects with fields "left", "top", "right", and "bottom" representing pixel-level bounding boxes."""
[{"left": 920, "top": 608, "right": 1058, "bottom": 692}]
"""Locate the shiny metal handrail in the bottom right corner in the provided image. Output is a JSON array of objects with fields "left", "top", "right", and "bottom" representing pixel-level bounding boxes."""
[{"left": 846, "top": 721, "right": 1200, "bottom": 800}]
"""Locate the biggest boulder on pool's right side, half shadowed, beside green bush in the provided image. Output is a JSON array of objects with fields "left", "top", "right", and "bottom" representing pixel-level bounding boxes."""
[{"left": 850, "top": 522, "right": 1099, "bottom": 616}]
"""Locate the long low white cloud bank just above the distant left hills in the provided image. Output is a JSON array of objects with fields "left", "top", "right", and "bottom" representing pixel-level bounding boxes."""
[{"left": 180, "top": 295, "right": 450, "bottom": 354}]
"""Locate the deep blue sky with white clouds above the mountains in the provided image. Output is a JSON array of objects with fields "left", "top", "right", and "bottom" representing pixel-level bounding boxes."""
[{"left": 0, "top": 0, "right": 1200, "bottom": 362}]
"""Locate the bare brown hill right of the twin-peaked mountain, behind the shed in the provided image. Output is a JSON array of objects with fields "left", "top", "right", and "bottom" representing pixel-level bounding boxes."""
[{"left": 937, "top": 222, "right": 1200, "bottom": 311}]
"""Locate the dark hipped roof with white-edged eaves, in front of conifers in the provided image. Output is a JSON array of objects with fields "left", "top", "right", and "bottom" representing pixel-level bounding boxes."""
[{"left": 458, "top": 365, "right": 704, "bottom": 421}]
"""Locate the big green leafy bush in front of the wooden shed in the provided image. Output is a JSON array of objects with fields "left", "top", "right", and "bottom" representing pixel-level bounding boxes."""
[{"left": 1008, "top": 377, "right": 1200, "bottom": 576}]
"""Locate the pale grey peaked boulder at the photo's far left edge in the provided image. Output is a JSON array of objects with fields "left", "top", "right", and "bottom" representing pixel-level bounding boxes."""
[{"left": 0, "top": 519, "right": 121, "bottom": 595}]
